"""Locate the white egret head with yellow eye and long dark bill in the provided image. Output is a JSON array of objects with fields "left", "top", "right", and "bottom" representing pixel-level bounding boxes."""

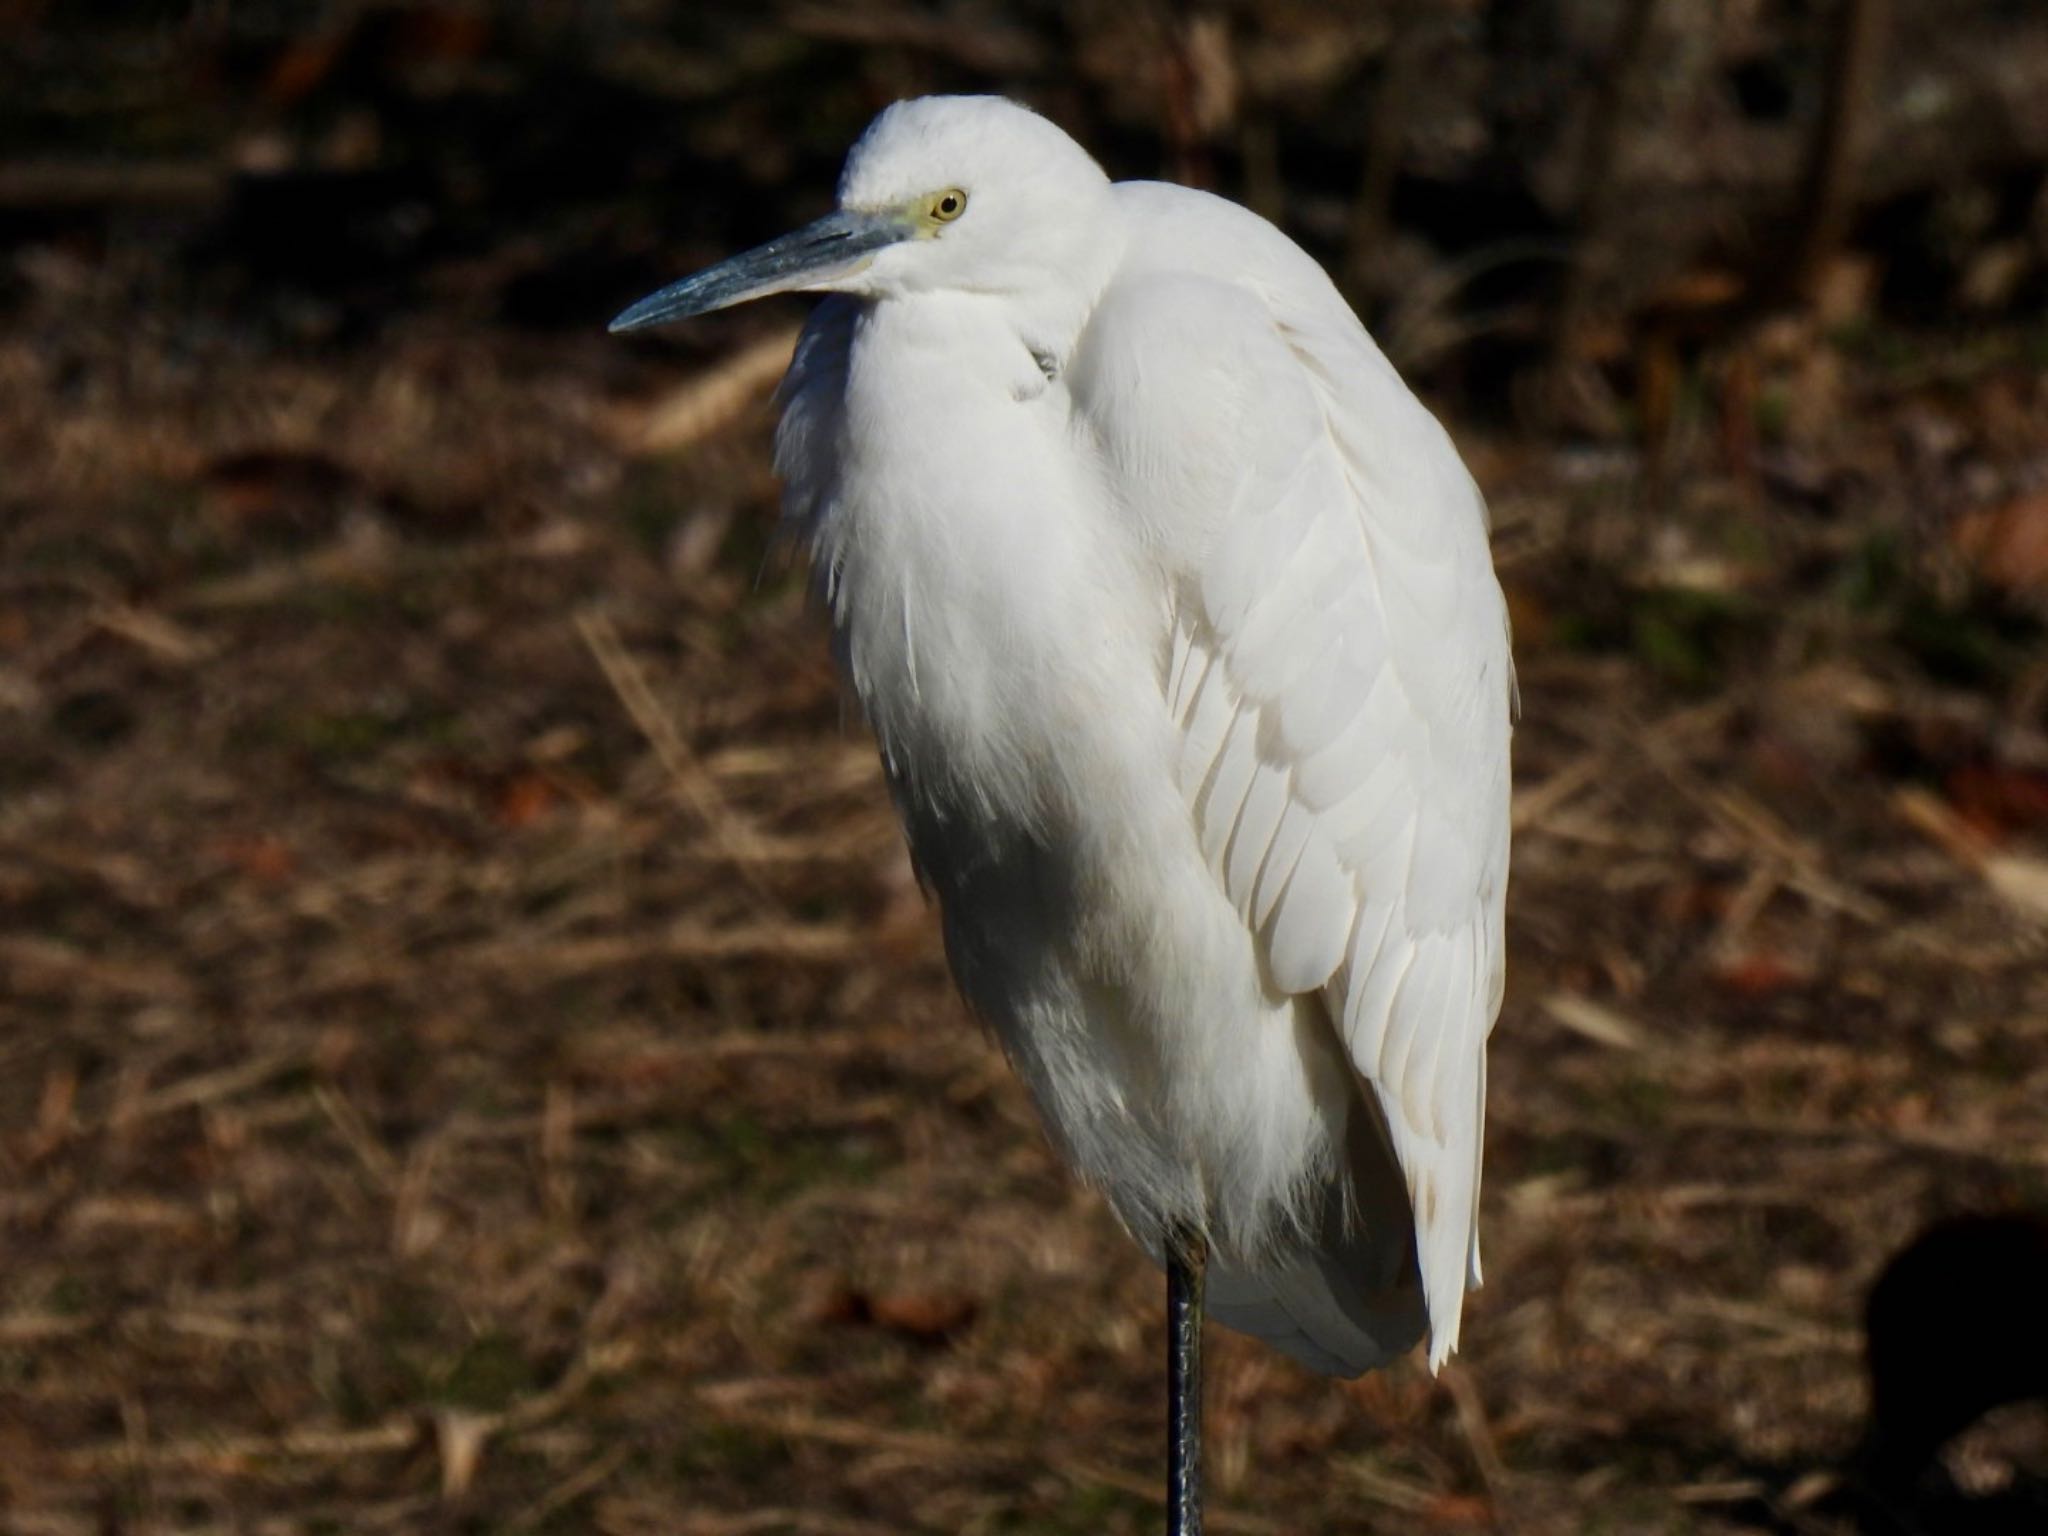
[{"left": 612, "top": 96, "right": 1110, "bottom": 332}]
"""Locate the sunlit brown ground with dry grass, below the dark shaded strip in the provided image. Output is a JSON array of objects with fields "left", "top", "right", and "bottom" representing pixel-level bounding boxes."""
[{"left": 0, "top": 8, "right": 2048, "bottom": 1536}]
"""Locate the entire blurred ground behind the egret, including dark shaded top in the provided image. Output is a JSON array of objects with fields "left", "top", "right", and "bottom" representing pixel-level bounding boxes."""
[{"left": 0, "top": 0, "right": 2048, "bottom": 1536}]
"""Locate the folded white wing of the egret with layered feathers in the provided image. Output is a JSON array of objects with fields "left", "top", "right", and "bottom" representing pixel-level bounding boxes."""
[{"left": 1077, "top": 228, "right": 1511, "bottom": 1364}]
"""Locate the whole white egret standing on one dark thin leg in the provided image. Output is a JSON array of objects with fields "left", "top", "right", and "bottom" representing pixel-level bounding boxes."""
[{"left": 612, "top": 96, "right": 1513, "bottom": 1532}]
